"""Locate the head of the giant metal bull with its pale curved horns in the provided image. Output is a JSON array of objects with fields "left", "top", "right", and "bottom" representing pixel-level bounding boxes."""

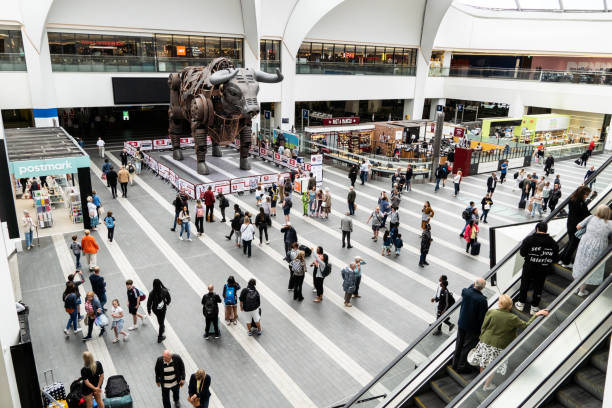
[{"left": 209, "top": 68, "right": 283, "bottom": 117}]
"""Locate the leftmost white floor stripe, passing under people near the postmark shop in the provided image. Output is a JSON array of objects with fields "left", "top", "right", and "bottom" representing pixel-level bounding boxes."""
[{"left": 52, "top": 235, "right": 117, "bottom": 377}]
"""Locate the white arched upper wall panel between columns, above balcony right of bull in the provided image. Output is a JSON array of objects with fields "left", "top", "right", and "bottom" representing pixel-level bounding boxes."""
[{"left": 306, "top": 0, "right": 425, "bottom": 46}]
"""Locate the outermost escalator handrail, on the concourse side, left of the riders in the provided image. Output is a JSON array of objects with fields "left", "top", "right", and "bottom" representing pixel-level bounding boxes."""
[{"left": 344, "top": 156, "right": 612, "bottom": 408}]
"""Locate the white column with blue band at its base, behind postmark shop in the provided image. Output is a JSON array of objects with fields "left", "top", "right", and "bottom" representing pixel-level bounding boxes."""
[{"left": 22, "top": 29, "right": 59, "bottom": 127}]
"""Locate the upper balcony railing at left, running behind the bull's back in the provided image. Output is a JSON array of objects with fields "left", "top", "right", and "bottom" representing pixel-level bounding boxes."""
[{"left": 50, "top": 54, "right": 242, "bottom": 72}]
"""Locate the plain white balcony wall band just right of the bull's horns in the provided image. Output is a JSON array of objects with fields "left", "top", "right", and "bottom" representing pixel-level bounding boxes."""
[{"left": 295, "top": 75, "right": 415, "bottom": 101}]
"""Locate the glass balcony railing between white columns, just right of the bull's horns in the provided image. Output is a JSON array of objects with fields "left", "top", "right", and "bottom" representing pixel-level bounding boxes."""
[{"left": 295, "top": 61, "right": 416, "bottom": 76}]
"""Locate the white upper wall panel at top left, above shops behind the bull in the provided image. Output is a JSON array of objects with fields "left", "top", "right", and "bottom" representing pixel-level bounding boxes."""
[{"left": 47, "top": 0, "right": 244, "bottom": 34}]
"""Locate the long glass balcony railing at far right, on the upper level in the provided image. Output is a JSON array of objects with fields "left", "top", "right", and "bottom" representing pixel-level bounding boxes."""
[{"left": 429, "top": 67, "right": 612, "bottom": 85}]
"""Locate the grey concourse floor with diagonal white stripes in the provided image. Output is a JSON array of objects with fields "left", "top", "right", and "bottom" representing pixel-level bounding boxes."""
[{"left": 19, "top": 149, "right": 612, "bottom": 407}]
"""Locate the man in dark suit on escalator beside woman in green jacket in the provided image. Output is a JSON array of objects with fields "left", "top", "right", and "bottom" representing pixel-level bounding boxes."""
[{"left": 452, "top": 278, "right": 488, "bottom": 373}]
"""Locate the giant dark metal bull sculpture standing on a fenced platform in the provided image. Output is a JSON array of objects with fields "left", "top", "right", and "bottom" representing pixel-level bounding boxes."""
[{"left": 168, "top": 58, "right": 283, "bottom": 174}]
